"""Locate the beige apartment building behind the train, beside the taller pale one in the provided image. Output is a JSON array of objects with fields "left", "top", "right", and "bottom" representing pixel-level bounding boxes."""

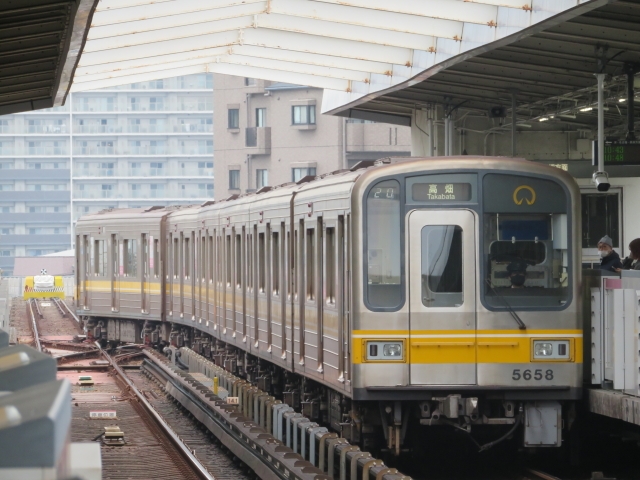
[{"left": 213, "top": 74, "right": 411, "bottom": 200}]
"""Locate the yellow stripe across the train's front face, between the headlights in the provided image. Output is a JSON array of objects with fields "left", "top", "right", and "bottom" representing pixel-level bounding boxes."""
[{"left": 352, "top": 330, "right": 583, "bottom": 364}]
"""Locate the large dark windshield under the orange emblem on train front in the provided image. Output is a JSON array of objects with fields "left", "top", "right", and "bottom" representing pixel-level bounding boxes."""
[{"left": 483, "top": 175, "right": 571, "bottom": 309}]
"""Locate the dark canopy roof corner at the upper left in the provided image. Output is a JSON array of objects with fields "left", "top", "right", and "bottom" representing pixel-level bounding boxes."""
[{"left": 0, "top": 0, "right": 98, "bottom": 115}]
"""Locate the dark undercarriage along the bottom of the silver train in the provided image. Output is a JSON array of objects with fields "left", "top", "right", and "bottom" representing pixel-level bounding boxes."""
[{"left": 83, "top": 317, "right": 576, "bottom": 457}]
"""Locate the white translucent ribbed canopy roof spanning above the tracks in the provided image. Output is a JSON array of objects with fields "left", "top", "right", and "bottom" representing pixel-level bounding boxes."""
[{"left": 72, "top": 0, "right": 606, "bottom": 98}]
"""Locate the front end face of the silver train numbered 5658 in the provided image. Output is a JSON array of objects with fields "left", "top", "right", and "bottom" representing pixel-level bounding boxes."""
[{"left": 352, "top": 157, "right": 582, "bottom": 453}]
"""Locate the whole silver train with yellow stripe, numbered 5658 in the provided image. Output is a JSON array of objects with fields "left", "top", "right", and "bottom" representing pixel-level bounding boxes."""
[{"left": 76, "top": 156, "right": 583, "bottom": 452}]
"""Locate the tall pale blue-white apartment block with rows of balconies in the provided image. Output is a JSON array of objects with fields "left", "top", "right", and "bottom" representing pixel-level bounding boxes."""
[{"left": 0, "top": 74, "right": 213, "bottom": 274}]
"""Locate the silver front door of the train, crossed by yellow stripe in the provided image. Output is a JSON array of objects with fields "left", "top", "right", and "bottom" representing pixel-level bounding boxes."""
[{"left": 407, "top": 210, "right": 477, "bottom": 385}]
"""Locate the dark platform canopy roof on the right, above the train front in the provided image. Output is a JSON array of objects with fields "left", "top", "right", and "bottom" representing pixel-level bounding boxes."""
[{"left": 323, "top": 0, "right": 640, "bottom": 135}]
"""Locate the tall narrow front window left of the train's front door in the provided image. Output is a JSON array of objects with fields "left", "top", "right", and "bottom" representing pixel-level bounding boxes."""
[{"left": 366, "top": 180, "right": 403, "bottom": 308}]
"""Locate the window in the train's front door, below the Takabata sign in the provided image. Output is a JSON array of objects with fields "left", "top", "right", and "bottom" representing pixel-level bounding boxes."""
[{"left": 421, "top": 225, "right": 464, "bottom": 307}]
